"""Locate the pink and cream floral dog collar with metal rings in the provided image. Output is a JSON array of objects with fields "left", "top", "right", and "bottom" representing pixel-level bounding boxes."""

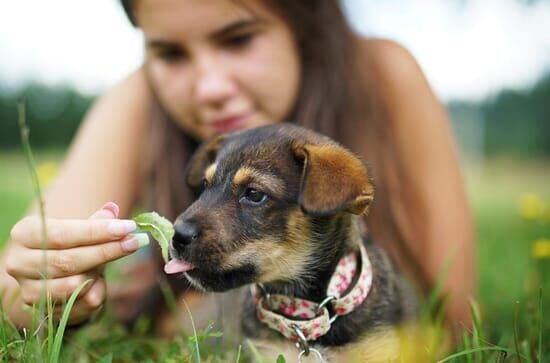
[{"left": 252, "top": 243, "right": 372, "bottom": 342}]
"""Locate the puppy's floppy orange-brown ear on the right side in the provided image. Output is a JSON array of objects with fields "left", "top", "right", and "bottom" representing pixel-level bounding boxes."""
[{"left": 292, "top": 142, "right": 374, "bottom": 216}]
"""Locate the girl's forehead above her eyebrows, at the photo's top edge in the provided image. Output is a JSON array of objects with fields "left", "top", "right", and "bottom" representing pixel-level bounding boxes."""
[{"left": 134, "top": 0, "right": 276, "bottom": 40}]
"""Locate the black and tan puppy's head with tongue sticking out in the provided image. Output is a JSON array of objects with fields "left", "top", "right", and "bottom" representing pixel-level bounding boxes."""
[{"left": 170, "top": 124, "right": 374, "bottom": 291}]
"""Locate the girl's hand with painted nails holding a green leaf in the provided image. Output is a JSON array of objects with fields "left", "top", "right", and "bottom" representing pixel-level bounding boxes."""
[{"left": 6, "top": 202, "right": 149, "bottom": 324}]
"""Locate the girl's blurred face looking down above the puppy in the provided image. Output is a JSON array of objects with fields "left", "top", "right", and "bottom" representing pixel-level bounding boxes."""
[{"left": 135, "top": 0, "right": 300, "bottom": 139}]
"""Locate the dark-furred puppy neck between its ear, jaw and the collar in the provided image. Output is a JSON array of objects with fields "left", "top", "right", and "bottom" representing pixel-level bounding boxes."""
[{"left": 264, "top": 213, "right": 362, "bottom": 302}]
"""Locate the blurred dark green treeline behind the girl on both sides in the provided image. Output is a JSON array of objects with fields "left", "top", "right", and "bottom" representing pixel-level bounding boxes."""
[{"left": 0, "top": 74, "right": 550, "bottom": 158}]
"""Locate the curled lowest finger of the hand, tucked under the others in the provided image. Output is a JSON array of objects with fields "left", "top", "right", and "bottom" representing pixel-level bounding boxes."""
[{"left": 53, "top": 278, "right": 107, "bottom": 324}]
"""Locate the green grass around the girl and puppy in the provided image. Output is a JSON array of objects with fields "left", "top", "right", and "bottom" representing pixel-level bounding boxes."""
[{"left": 0, "top": 151, "right": 550, "bottom": 363}]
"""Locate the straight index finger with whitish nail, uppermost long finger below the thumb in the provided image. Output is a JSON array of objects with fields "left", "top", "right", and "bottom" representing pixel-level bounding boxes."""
[{"left": 11, "top": 216, "right": 137, "bottom": 249}]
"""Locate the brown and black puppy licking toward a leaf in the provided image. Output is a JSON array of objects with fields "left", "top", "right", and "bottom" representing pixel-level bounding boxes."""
[{"left": 169, "top": 124, "right": 415, "bottom": 362}]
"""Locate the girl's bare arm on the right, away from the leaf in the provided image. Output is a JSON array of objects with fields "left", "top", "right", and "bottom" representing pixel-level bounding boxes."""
[{"left": 366, "top": 40, "right": 477, "bottom": 332}]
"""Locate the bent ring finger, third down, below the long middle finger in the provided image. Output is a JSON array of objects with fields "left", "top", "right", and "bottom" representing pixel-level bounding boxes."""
[{"left": 19, "top": 272, "right": 98, "bottom": 305}]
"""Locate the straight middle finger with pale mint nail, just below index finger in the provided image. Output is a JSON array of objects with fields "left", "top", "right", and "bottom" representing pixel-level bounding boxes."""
[{"left": 12, "top": 233, "right": 149, "bottom": 279}]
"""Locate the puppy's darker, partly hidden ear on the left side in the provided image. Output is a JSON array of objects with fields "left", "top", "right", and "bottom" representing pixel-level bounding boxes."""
[{"left": 186, "top": 135, "right": 226, "bottom": 189}]
